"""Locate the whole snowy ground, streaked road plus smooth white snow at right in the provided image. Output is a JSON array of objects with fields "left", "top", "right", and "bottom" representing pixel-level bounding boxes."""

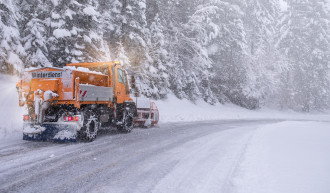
[{"left": 0, "top": 120, "right": 330, "bottom": 193}]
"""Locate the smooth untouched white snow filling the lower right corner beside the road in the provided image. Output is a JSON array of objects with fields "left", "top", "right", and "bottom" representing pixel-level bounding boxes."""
[{"left": 229, "top": 121, "right": 330, "bottom": 193}]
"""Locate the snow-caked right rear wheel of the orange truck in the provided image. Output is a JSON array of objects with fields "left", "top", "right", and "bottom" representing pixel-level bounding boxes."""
[{"left": 78, "top": 112, "right": 99, "bottom": 142}]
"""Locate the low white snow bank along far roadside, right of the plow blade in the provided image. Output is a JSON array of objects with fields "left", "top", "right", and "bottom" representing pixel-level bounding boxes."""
[{"left": 156, "top": 95, "right": 330, "bottom": 123}]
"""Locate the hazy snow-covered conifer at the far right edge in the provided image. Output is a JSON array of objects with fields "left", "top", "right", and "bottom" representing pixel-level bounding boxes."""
[{"left": 279, "top": 0, "right": 330, "bottom": 112}]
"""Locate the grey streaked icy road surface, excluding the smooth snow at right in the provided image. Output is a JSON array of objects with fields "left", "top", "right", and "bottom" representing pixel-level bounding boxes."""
[{"left": 0, "top": 121, "right": 278, "bottom": 192}]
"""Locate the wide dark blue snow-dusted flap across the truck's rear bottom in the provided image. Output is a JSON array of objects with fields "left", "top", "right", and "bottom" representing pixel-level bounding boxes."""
[{"left": 23, "top": 123, "right": 77, "bottom": 143}]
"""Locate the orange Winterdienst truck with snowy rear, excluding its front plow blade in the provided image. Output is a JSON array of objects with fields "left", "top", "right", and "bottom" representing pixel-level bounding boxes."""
[{"left": 17, "top": 61, "right": 158, "bottom": 142}]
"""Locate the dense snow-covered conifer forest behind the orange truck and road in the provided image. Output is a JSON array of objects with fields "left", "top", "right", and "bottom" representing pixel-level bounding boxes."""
[{"left": 0, "top": 0, "right": 330, "bottom": 112}]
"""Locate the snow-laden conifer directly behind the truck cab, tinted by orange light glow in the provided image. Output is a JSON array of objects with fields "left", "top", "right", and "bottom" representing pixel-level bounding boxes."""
[{"left": 115, "top": 0, "right": 157, "bottom": 96}]
